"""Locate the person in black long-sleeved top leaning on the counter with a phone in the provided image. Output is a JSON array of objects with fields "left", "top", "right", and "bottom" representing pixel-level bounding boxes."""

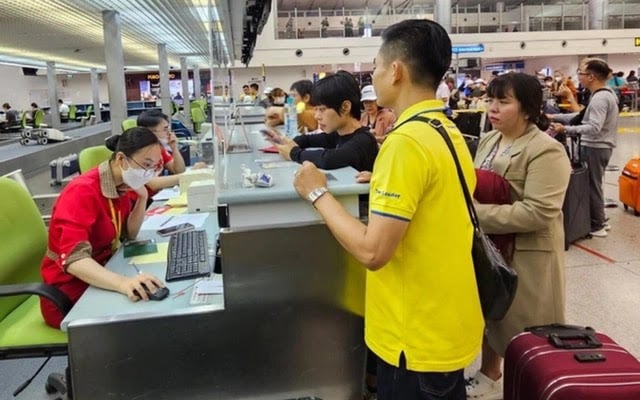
[{"left": 270, "top": 71, "right": 378, "bottom": 171}]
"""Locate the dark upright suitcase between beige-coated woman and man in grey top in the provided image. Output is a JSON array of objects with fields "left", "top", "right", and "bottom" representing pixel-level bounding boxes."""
[{"left": 562, "top": 136, "right": 591, "bottom": 250}]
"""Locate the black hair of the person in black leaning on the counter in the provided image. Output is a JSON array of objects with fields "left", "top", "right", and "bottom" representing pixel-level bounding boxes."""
[{"left": 311, "top": 71, "right": 361, "bottom": 120}]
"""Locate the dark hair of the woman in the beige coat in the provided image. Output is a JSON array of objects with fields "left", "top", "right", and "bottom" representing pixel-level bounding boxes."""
[{"left": 487, "top": 72, "right": 550, "bottom": 131}]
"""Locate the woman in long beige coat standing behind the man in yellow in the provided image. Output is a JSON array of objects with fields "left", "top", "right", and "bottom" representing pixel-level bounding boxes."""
[{"left": 467, "top": 73, "right": 571, "bottom": 399}]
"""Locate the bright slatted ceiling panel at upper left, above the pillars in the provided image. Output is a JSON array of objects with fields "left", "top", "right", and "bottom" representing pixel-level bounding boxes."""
[{"left": 0, "top": 0, "right": 218, "bottom": 67}]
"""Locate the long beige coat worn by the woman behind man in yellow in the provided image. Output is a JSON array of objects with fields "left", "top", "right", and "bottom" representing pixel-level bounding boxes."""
[{"left": 475, "top": 124, "right": 571, "bottom": 356}]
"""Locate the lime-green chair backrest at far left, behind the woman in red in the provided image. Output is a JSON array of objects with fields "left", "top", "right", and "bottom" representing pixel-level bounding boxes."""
[{"left": 0, "top": 177, "right": 47, "bottom": 320}]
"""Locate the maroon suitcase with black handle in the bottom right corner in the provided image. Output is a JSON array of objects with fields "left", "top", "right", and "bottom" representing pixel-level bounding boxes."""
[{"left": 504, "top": 324, "right": 640, "bottom": 400}]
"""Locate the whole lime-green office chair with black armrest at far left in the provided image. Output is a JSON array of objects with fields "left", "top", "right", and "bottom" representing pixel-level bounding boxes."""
[{"left": 0, "top": 177, "right": 72, "bottom": 396}]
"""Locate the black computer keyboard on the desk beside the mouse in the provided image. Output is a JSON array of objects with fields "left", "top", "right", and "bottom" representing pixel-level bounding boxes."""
[{"left": 165, "top": 231, "right": 211, "bottom": 282}]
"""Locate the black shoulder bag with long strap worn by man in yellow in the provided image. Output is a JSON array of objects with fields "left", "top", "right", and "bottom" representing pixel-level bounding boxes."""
[{"left": 413, "top": 116, "right": 518, "bottom": 321}]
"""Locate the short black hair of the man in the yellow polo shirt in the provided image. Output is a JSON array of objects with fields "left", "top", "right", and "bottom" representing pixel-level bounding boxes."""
[{"left": 380, "top": 19, "right": 451, "bottom": 91}]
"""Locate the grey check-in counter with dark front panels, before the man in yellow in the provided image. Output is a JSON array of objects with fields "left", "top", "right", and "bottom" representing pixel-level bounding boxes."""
[{"left": 63, "top": 123, "right": 368, "bottom": 400}]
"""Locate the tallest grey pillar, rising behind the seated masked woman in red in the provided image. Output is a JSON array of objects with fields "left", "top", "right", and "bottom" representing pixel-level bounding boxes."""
[{"left": 102, "top": 10, "right": 127, "bottom": 135}]
